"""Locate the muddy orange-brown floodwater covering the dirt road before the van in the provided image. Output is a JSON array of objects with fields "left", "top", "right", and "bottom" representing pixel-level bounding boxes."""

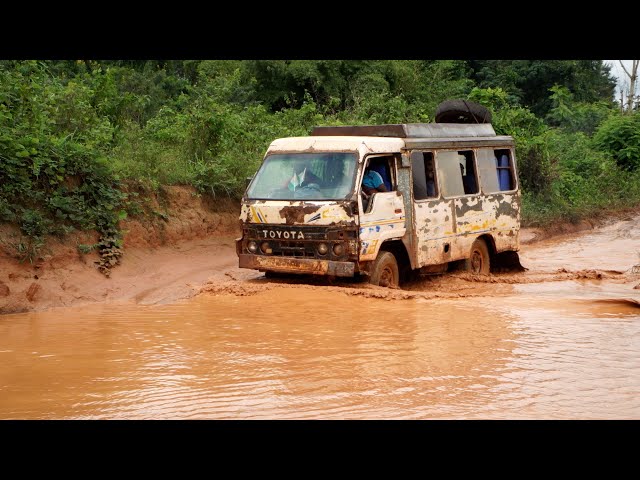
[{"left": 0, "top": 216, "right": 640, "bottom": 419}]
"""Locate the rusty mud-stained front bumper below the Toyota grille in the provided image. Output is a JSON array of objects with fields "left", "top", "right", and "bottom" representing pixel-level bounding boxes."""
[{"left": 238, "top": 254, "right": 355, "bottom": 277}]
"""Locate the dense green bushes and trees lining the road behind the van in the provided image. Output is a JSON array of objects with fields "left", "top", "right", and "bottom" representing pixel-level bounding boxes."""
[{"left": 0, "top": 60, "right": 640, "bottom": 274}]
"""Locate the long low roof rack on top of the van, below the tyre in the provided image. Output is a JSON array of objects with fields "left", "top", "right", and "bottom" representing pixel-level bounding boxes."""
[{"left": 311, "top": 123, "right": 496, "bottom": 138}]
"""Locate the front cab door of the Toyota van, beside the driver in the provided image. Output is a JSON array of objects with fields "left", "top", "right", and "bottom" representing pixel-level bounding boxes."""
[{"left": 358, "top": 155, "right": 406, "bottom": 261}]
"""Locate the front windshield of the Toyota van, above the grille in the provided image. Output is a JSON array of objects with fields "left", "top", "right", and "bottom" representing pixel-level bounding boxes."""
[{"left": 247, "top": 152, "right": 356, "bottom": 200}]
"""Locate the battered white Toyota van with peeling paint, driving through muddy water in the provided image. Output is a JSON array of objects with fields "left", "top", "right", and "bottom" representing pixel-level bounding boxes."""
[{"left": 236, "top": 123, "right": 520, "bottom": 286}]
